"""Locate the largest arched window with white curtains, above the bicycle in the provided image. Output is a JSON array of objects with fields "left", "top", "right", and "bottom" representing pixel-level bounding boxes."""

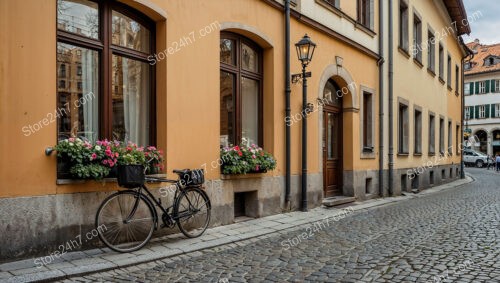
[{"left": 54, "top": 0, "right": 156, "bottom": 145}]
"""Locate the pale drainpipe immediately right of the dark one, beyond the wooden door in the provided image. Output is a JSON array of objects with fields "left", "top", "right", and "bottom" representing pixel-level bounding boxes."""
[{"left": 389, "top": 0, "right": 394, "bottom": 195}]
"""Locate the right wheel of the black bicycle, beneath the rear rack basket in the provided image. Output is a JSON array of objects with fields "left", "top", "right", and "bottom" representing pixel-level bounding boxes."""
[{"left": 174, "top": 188, "right": 211, "bottom": 238}]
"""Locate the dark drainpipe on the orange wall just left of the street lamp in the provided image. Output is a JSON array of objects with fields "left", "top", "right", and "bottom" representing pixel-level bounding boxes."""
[{"left": 285, "top": 0, "right": 292, "bottom": 209}]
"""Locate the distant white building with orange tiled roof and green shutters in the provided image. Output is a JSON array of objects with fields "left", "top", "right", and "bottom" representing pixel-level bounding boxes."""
[{"left": 464, "top": 39, "right": 500, "bottom": 155}]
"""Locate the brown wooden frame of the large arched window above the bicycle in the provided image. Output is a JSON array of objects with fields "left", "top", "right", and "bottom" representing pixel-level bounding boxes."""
[{"left": 55, "top": 0, "right": 156, "bottom": 145}]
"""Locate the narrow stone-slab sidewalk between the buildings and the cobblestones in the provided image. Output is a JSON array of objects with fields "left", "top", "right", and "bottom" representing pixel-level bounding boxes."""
[{"left": 0, "top": 176, "right": 473, "bottom": 282}]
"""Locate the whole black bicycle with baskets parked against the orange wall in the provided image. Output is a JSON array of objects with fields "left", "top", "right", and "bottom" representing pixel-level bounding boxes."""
[{"left": 95, "top": 166, "right": 211, "bottom": 252}]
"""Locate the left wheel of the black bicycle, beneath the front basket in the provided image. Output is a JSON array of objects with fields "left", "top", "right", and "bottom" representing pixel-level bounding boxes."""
[{"left": 96, "top": 190, "right": 156, "bottom": 252}]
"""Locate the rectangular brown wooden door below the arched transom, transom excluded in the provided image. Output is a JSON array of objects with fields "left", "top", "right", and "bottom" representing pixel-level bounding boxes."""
[{"left": 323, "top": 107, "right": 342, "bottom": 197}]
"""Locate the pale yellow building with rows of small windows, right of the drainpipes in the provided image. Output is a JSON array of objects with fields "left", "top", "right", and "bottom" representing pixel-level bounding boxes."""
[{"left": 384, "top": 0, "right": 472, "bottom": 192}]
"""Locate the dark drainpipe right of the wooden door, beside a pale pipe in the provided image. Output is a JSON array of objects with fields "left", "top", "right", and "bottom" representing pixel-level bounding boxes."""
[{"left": 377, "top": 1, "right": 384, "bottom": 197}]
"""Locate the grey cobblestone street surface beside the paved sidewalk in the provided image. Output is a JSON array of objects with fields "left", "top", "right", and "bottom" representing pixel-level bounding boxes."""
[{"left": 67, "top": 168, "right": 500, "bottom": 282}]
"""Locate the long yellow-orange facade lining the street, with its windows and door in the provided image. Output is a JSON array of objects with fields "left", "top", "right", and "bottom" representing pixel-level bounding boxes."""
[{"left": 0, "top": 0, "right": 466, "bottom": 260}]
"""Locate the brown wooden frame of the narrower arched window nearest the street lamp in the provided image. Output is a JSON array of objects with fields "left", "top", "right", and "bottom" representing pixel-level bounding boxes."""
[{"left": 219, "top": 32, "right": 264, "bottom": 147}]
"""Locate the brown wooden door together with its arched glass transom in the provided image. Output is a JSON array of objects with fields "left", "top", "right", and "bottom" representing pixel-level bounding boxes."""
[{"left": 322, "top": 79, "right": 343, "bottom": 197}]
